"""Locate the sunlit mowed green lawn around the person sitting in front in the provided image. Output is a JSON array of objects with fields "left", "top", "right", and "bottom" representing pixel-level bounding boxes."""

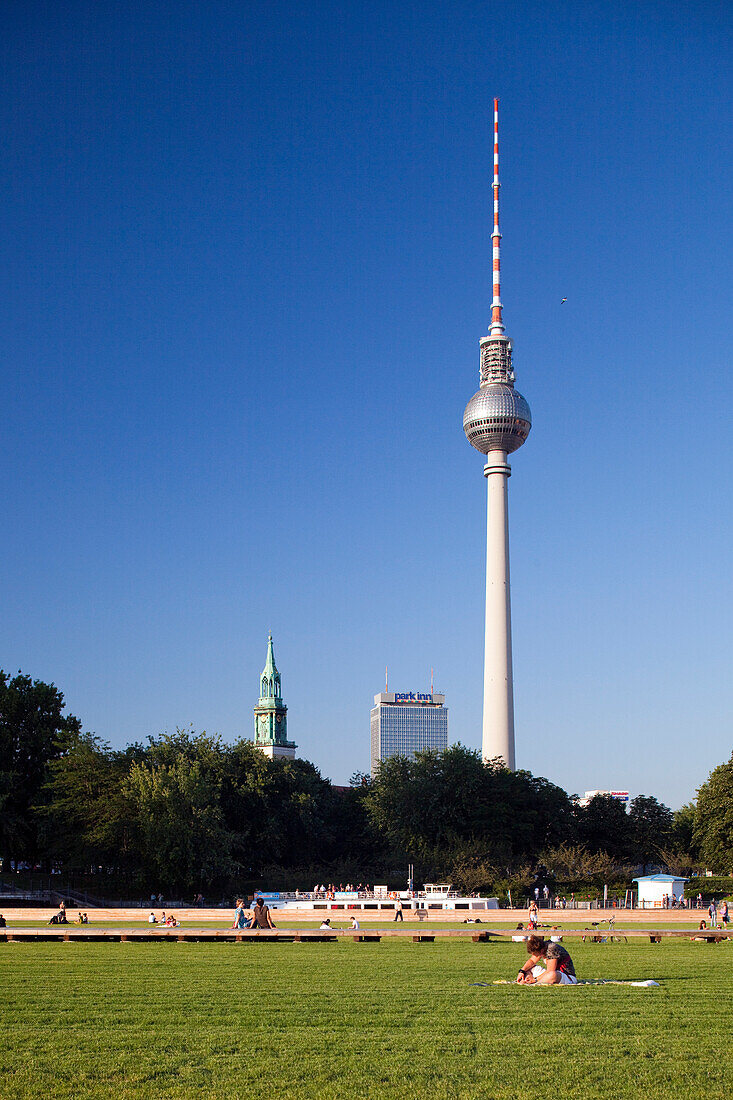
[{"left": 0, "top": 941, "right": 733, "bottom": 1100}]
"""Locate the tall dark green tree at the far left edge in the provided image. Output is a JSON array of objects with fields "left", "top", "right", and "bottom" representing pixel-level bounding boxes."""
[{"left": 0, "top": 669, "right": 81, "bottom": 862}]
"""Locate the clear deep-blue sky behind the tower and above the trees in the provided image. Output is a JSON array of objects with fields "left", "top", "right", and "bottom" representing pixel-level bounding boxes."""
[{"left": 0, "top": 0, "right": 733, "bottom": 806}]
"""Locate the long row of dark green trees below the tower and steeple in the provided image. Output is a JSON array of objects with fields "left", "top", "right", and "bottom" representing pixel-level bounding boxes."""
[{"left": 0, "top": 671, "right": 733, "bottom": 894}]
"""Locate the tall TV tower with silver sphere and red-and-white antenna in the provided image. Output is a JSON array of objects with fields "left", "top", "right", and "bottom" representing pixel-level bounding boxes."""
[{"left": 463, "top": 99, "right": 532, "bottom": 770}]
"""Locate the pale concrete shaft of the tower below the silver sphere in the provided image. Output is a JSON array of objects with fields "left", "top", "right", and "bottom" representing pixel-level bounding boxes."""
[{"left": 481, "top": 451, "right": 514, "bottom": 770}]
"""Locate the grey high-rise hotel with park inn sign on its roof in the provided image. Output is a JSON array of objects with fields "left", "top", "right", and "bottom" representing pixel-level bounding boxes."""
[{"left": 371, "top": 692, "right": 448, "bottom": 776}]
